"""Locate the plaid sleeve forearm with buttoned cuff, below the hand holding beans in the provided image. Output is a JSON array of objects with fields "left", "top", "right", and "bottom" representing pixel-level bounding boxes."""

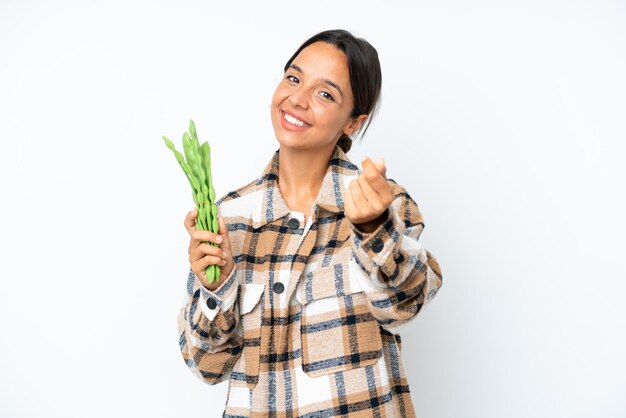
[{"left": 178, "top": 266, "right": 243, "bottom": 384}]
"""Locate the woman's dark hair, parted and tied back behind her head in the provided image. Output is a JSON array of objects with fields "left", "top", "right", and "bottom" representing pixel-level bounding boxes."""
[{"left": 284, "top": 29, "right": 382, "bottom": 152}]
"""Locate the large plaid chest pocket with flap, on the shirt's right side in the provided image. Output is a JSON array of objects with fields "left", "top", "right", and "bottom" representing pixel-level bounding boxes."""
[{"left": 296, "top": 263, "right": 382, "bottom": 377}]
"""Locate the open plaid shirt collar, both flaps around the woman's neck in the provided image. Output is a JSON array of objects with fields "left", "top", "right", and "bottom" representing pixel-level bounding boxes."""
[{"left": 253, "top": 146, "right": 359, "bottom": 228}]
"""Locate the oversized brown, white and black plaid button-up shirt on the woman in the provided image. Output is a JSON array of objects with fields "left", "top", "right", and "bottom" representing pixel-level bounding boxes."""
[{"left": 178, "top": 147, "right": 442, "bottom": 418}]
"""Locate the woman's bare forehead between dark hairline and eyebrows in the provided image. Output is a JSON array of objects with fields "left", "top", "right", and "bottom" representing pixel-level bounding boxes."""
[{"left": 292, "top": 42, "right": 350, "bottom": 90}]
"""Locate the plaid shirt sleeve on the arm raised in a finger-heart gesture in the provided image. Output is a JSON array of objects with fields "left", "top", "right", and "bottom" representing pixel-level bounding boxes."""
[{"left": 350, "top": 180, "right": 442, "bottom": 328}]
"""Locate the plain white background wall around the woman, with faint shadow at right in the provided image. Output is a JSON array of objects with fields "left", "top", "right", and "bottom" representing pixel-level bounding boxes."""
[{"left": 0, "top": 0, "right": 626, "bottom": 418}]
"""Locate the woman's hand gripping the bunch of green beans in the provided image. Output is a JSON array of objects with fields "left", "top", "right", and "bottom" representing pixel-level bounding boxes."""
[{"left": 185, "top": 208, "right": 235, "bottom": 290}]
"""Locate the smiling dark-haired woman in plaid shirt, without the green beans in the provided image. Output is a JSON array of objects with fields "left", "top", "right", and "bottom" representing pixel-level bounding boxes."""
[{"left": 178, "top": 30, "right": 441, "bottom": 417}]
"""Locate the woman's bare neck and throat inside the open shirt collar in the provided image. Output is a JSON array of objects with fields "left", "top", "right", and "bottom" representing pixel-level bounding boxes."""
[{"left": 278, "top": 146, "right": 334, "bottom": 214}]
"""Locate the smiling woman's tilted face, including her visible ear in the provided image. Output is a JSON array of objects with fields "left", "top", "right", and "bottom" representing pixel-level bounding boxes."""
[{"left": 271, "top": 42, "right": 365, "bottom": 153}]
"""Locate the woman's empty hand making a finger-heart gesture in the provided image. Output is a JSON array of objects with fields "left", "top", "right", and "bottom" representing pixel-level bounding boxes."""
[{"left": 344, "top": 157, "right": 394, "bottom": 232}]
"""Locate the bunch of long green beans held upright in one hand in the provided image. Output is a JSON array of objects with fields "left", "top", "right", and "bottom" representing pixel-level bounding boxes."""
[{"left": 163, "top": 120, "right": 220, "bottom": 283}]
